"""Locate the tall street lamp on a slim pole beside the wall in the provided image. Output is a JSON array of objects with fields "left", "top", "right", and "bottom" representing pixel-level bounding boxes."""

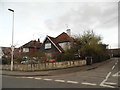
[{"left": 8, "top": 9, "right": 14, "bottom": 71}]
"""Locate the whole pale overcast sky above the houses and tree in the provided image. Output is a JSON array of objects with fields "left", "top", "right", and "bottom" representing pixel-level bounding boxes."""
[{"left": 0, "top": 2, "right": 118, "bottom": 48}]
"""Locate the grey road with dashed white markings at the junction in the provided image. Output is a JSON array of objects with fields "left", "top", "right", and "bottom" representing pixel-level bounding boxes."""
[{"left": 2, "top": 58, "right": 120, "bottom": 88}]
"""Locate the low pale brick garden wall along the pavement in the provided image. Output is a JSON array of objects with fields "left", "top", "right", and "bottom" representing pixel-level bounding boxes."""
[{"left": 2, "top": 60, "right": 86, "bottom": 71}]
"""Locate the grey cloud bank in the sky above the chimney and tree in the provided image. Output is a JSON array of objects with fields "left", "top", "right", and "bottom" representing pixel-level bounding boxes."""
[{"left": 46, "top": 3, "right": 118, "bottom": 30}]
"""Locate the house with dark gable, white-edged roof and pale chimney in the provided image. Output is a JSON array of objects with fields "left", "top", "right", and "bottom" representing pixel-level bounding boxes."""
[{"left": 40, "top": 29, "right": 74, "bottom": 59}]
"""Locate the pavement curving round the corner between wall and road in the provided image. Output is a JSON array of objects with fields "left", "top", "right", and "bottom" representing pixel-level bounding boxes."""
[{"left": 0, "top": 59, "right": 111, "bottom": 76}]
